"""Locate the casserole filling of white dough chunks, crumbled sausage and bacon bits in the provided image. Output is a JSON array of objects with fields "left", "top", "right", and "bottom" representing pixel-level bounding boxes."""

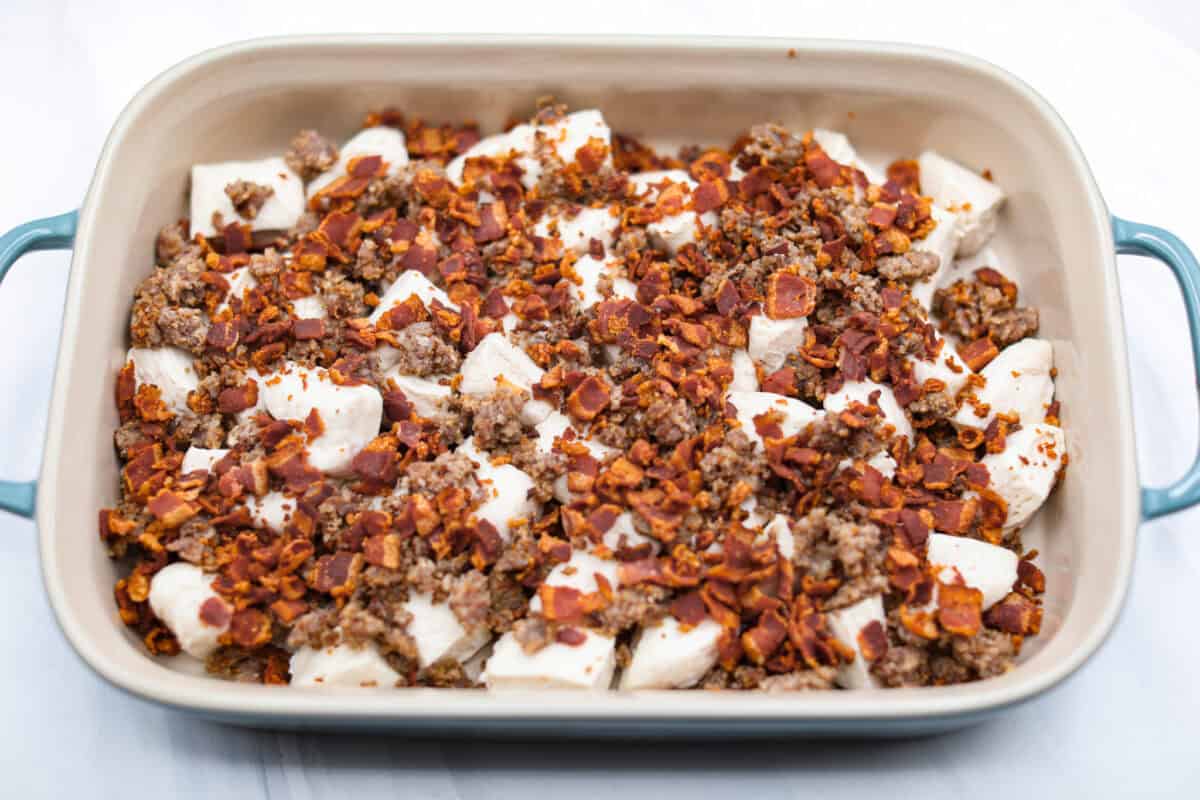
[{"left": 100, "top": 106, "right": 1067, "bottom": 691}]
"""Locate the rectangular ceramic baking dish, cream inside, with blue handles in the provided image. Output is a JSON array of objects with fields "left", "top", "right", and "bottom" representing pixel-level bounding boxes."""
[{"left": 0, "top": 36, "right": 1200, "bottom": 736}]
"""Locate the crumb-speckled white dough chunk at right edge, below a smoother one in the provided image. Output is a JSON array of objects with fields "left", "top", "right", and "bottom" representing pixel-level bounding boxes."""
[{"left": 983, "top": 423, "right": 1067, "bottom": 528}]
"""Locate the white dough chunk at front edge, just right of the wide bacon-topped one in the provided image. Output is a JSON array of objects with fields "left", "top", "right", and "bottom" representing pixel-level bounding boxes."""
[{"left": 620, "top": 616, "right": 721, "bottom": 691}]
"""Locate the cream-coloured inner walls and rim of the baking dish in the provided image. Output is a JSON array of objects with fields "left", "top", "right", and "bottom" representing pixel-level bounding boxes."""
[{"left": 40, "top": 40, "right": 1136, "bottom": 714}]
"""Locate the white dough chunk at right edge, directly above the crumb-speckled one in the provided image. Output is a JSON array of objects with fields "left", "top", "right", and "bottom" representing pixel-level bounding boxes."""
[{"left": 954, "top": 338, "right": 1054, "bottom": 428}]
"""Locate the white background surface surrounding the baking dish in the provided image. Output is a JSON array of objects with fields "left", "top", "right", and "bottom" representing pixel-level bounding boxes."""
[{"left": 0, "top": 0, "right": 1200, "bottom": 799}]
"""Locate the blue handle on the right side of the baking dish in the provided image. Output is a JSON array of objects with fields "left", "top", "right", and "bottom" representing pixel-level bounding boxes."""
[{"left": 1112, "top": 217, "right": 1200, "bottom": 519}]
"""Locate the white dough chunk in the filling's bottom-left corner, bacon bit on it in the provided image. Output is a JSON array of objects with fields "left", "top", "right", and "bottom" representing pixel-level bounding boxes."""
[{"left": 149, "top": 561, "right": 233, "bottom": 658}]
